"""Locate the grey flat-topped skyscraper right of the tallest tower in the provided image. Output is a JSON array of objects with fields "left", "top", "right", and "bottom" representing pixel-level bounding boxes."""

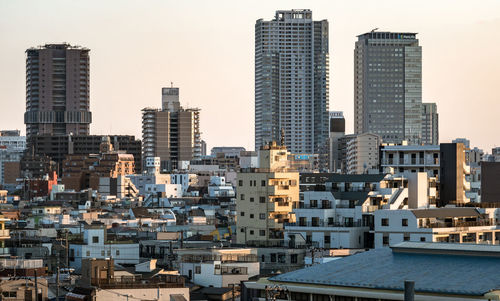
[{"left": 354, "top": 31, "right": 422, "bottom": 144}]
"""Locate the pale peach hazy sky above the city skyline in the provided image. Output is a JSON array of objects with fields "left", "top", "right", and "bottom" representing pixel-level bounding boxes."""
[{"left": 0, "top": 0, "right": 500, "bottom": 152}]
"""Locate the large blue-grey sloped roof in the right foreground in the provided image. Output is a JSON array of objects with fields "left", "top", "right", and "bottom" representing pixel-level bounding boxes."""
[{"left": 269, "top": 247, "right": 500, "bottom": 296}]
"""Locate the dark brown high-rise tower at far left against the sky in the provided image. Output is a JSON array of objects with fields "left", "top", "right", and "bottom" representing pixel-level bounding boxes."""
[{"left": 24, "top": 44, "right": 92, "bottom": 141}]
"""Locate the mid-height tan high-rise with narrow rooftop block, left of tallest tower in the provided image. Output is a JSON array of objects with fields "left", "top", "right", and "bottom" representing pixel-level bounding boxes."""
[{"left": 142, "top": 87, "right": 202, "bottom": 170}]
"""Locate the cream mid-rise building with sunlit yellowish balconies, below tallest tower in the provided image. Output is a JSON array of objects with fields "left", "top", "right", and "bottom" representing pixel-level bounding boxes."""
[{"left": 236, "top": 142, "right": 299, "bottom": 246}]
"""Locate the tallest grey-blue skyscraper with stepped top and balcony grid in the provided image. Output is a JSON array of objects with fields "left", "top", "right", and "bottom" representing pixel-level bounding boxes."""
[{"left": 255, "top": 10, "right": 329, "bottom": 153}]
